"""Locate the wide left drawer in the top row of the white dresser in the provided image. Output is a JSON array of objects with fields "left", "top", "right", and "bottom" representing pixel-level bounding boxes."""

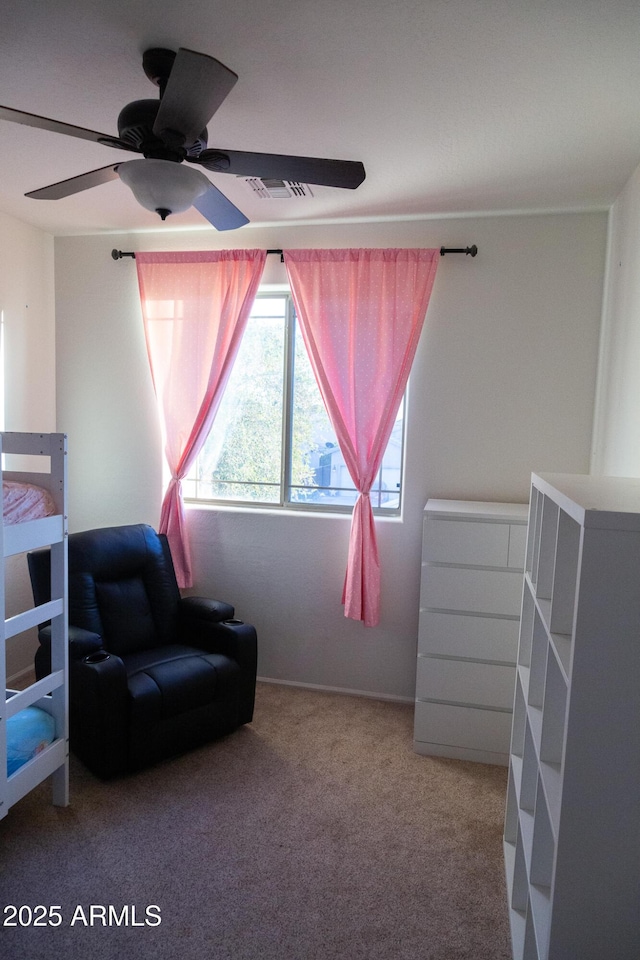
[{"left": 423, "top": 516, "right": 509, "bottom": 567}]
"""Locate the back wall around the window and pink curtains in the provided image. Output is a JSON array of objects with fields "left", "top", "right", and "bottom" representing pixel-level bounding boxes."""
[{"left": 55, "top": 213, "right": 607, "bottom": 698}]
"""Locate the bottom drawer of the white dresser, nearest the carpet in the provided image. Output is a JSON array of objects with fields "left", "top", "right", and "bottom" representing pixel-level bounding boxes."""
[{"left": 414, "top": 702, "right": 511, "bottom": 754}]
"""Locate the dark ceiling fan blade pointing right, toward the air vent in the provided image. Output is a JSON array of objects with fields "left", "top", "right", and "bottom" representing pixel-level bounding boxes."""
[{"left": 187, "top": 149, "right": 366, "bottom": 190}]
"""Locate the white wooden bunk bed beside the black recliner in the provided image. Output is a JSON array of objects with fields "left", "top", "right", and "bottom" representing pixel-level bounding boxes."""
[{"left": 0, "top": 433, "right": 69, "bottom": 819}]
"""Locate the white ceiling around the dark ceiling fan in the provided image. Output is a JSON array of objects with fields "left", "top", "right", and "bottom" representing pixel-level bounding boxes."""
[{"left": 0, "top": 0, "right": 640, "bottom": 235}]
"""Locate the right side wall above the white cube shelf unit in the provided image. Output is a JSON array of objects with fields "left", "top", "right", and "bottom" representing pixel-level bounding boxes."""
[{"left": 592, "top": 167, "right": 640, "bottom": 477}]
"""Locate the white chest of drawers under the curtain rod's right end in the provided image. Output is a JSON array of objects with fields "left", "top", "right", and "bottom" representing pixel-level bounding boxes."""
[{"left": 414, "top": 500, "right": 528, "bottom": 765}]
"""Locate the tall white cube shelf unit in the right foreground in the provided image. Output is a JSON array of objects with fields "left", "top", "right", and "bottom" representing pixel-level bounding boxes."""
[{"left": 504, "top": 474, "right": 640, "bottom": 960}]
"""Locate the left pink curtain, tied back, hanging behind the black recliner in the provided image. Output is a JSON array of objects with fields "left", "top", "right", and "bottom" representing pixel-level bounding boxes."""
[{"left": 136, "top": 250, "right": 266, "bottom": 587}]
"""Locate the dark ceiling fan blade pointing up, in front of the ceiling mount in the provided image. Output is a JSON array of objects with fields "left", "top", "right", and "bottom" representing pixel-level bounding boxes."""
[{"left": 153, "top": 47, "right": 238, "bottom": 146}]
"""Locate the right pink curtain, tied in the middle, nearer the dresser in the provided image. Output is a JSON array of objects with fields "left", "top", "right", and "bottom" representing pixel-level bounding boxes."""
[{"left": 284, "top": 249, "right": 440, "bottom": 626}]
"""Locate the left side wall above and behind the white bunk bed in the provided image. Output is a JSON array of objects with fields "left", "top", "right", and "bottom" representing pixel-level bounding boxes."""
[{"left": 0, "top": 213, "right": 56, "bottom": 677}]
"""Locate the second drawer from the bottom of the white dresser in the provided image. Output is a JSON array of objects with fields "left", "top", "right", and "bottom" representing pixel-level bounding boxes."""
[{"left": 416, "top": 657, "right": 516, "bottom": 710}]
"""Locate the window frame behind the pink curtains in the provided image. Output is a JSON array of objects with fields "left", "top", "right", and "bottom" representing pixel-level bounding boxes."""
[{"left": 184, "top": 284, "right": 409, "bottom": 518}]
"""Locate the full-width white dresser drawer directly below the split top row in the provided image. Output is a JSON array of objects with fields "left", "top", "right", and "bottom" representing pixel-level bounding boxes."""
[{"left": 420, "top": 563, "right": 522, "bottom": 617}]
